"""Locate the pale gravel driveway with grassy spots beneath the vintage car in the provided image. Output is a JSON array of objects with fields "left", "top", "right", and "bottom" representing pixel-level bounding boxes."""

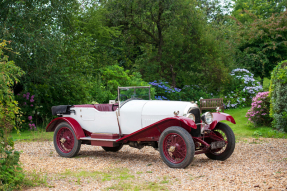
[{"left": 16, "top": 139, "right": 287, "bottom": 190}]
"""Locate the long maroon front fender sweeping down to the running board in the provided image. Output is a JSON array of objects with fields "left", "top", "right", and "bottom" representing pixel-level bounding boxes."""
[{"left": 117, "top": 116, "right": 197, "bottom": 142}]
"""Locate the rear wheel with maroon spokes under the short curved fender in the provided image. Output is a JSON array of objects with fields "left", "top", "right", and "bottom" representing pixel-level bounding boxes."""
[{"left": 54, "top": 122, "right": 81, "bottom": 158}]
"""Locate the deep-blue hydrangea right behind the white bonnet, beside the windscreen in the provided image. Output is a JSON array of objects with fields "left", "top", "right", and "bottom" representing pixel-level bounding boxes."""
[{"left": 149, "top": 80, "right": 181, "bottom": 100}]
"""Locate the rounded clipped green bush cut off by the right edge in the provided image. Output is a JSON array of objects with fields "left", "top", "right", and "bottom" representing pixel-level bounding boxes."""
[{"left": 269, "top": 60, "right": 287, "bottom": 132}]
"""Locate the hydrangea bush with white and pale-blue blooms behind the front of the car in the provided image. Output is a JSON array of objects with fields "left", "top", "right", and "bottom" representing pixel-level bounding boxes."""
[{"left": 223, "top": 68, "right": 263, "bottom": 108}]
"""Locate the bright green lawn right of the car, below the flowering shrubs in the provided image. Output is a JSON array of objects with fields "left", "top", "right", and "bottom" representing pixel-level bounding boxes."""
[{"left": 223, "top": 108, "right": 287, "bottom": 138}]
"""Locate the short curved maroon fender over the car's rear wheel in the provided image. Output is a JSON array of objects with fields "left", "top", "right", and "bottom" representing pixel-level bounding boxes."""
[{"left": 46, "top": 117, "right": 85, "bottom": 140}]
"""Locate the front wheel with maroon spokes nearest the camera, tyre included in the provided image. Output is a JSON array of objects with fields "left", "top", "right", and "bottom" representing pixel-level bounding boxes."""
[{"left": 159, "top": 126, "right": 195, "bottom": 168}]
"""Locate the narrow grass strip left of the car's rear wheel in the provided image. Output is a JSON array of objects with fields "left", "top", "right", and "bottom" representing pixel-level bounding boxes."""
[{"left": 10, "top": 128, "right": 54, "bottom": 141}]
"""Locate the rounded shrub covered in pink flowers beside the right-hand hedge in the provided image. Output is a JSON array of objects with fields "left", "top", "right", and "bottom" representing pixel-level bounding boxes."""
[{"left": 245, "top": 92, "right": 272, "bottom": 126}]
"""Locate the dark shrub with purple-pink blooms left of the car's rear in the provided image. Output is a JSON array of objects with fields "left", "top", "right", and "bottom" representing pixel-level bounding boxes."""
[{"left": 17, "top": 92, "right": 37, "bottom": 130}]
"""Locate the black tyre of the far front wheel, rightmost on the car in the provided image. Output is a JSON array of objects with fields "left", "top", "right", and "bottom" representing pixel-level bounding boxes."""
[{"left": 205, "top": 122, "right": 235, "bottom": 161}]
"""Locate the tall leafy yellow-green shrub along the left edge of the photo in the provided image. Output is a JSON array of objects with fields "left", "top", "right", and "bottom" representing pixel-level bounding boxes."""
[{"left": 0, "top": 40, "right": 24, "bottom": 190}]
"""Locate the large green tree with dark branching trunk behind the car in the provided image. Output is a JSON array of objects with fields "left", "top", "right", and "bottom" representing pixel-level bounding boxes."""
[{"left": 103, "top": 0, "right": 232, "bottom": 91}]
